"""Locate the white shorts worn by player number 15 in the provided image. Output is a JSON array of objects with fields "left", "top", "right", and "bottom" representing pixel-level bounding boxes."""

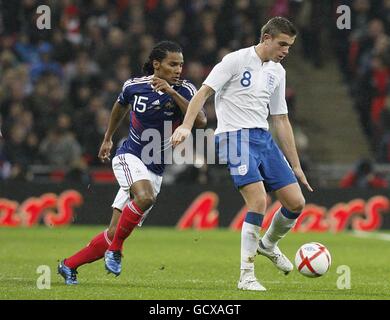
[{"left": 111, "top": 153, "right": 162, "bottom": 225}]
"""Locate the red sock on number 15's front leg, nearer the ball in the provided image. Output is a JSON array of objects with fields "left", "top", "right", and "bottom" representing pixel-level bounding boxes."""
[{"left": 108, "top": 201, "right": 144, "bottom": 251}]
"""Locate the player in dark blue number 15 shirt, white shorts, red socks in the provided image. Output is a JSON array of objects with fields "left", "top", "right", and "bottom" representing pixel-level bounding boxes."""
[{"left": 58, "top": 41, "right": 207, "bottom": 285}]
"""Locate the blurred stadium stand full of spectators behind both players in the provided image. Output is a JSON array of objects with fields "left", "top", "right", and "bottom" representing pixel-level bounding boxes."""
[{"left": 0, "top": 0, "right": 390, "bottom": 185}]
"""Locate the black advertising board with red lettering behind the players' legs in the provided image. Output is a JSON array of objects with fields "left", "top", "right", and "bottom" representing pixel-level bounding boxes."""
[{"left": 0, "top": 182, "right": 390, "bottom": 232}]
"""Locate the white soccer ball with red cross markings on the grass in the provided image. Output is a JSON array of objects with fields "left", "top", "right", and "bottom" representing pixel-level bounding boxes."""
[{"left": 295, "top": 242, "right": 332, "bottom": 278}]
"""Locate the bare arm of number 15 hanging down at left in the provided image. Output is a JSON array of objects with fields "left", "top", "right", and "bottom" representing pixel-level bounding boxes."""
[{"left": 98, "top": 102, "right": 129, "bottom": 163}]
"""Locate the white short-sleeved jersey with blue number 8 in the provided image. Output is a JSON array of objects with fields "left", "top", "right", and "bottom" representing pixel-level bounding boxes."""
[{"left": 203, "top": 46, "right": 288, "bottom": 134}]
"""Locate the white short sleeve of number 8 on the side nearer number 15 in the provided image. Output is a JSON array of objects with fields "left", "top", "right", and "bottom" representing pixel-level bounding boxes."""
[{"left": 203, "top": 52, "right": 239, "bottom": 92}]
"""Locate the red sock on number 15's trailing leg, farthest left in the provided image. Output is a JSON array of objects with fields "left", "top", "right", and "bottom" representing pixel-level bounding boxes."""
[{"left": 64, "top": 230, "right": 111, "bottom": 269}]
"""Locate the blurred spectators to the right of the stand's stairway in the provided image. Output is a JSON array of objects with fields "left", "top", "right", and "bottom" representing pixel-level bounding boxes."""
[{"left": 335, "top": 0, "right": 390, "bottom": 163}]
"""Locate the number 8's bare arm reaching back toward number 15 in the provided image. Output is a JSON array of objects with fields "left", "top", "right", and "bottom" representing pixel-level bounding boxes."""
[{"left": 171, "top": 85, "right": 214, "bottom": 147}]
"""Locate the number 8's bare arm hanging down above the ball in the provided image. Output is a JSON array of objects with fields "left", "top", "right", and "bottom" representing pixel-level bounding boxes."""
[{"left": 272, "top": 114, "right": 313, "bottom": 191}]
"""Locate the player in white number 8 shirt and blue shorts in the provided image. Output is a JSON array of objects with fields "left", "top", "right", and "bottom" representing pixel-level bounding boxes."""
[{"left": 171, "top": 17, "right": 313, "bottom": 291}]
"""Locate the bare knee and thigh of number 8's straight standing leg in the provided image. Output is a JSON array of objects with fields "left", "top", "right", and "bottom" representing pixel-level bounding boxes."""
[{"left": 239, "top": 181, "right": 267, "bottom": 213}]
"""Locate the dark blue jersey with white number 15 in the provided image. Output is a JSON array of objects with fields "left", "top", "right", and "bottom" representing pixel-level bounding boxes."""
[{"left": 116, "top": 75, "right": 196, "bottom": 175}]
